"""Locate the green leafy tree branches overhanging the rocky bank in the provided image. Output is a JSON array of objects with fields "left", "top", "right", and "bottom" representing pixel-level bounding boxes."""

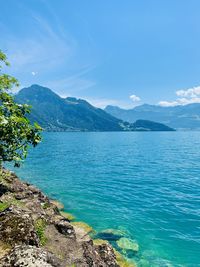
[{"left": 0, "top": 50, "right": 42, "bottom": 167}]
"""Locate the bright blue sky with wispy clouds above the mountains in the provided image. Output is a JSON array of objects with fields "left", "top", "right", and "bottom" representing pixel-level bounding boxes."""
[{"left": 0, "top": 0, "right": 200, "bottom": 108}]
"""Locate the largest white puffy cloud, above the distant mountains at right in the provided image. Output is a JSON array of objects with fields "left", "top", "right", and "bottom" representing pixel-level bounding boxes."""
[{"left": 158, "top": 86, "right": 200, "bottom": 107}]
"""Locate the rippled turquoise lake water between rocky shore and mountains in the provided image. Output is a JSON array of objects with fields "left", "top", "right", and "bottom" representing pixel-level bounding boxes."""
[{"left": 11, "top": 132, "right": 200, "bottom": 267}]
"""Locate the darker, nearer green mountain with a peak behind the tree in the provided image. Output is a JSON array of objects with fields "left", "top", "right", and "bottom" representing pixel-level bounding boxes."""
[{"left": 15, "top": 84, "right": 173, "bottom": 131}]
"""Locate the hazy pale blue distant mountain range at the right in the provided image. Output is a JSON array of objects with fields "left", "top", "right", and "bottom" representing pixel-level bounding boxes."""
[{"left": 105, "top": 103, "right": 200, "bottom": 130}]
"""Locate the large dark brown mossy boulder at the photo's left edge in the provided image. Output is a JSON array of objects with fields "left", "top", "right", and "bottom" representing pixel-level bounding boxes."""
[{"left": 0, "top": 206, "right": 39, "bottom": 246}]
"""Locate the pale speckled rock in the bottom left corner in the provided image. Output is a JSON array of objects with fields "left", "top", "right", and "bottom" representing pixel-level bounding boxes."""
[{"left": 0, "top": 245, "right": 64, "bottom": 267}]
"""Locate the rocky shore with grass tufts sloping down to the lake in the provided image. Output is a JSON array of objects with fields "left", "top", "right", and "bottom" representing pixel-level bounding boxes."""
[{"left": 0, "top": 169, "right": 132, "bottom": 267}]
